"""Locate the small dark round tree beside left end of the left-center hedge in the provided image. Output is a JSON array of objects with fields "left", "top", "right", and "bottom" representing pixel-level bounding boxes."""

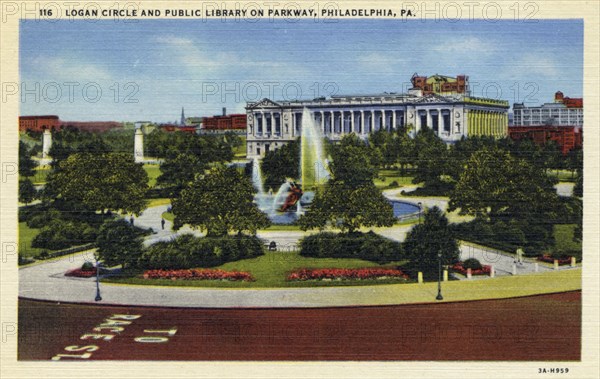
[{"left": 96, "top": 219, "right": 143, "bottom": 269}]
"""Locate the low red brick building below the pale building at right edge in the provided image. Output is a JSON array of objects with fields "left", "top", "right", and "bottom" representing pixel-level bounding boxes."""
[{"left": 508, "top": 125, "right": 583, "bottom": 155}]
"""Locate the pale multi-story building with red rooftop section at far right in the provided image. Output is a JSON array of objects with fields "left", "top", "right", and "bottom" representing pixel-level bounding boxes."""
[{"left": 513, "top": 91, "right": 583, "bottom": 127}]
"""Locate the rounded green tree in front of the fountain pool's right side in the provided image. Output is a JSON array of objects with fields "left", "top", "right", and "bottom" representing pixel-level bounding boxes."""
[{"left": 298, "top": 179, "right": 396, "bottom": 233}]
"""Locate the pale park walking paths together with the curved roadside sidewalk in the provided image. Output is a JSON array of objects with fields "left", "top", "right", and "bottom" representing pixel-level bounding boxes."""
[{"left": 19, "top": 193, "right": 581, "bottom": 308}]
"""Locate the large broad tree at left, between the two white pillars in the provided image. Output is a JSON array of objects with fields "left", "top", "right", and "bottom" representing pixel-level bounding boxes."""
[{"left": 45, "top": 153, "right": 148, "bottom": 214}]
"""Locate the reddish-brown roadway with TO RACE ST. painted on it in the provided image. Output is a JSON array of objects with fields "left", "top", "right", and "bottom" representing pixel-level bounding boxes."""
[{"left": 18, "top": 291, "right": 581, "bottom": 361}]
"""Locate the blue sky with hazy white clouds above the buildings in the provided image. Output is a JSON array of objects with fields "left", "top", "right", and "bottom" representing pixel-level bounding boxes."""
[{"left": 20, "top": 19, "right": 583, "bottom": 121}]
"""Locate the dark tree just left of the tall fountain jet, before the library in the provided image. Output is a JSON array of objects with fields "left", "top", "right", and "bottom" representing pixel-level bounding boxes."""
[{"left": 261, "top": 138, "right": 300, "bottom": 191}]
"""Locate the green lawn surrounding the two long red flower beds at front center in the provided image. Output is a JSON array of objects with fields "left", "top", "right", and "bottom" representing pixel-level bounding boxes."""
[{"left": 104, "top": 252, "right": 404, "bottom": 288}]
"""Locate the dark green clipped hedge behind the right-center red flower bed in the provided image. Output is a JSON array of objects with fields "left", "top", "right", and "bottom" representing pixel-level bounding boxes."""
[{"left": 300, "top": 232, "right": 403, "bottom": 263}]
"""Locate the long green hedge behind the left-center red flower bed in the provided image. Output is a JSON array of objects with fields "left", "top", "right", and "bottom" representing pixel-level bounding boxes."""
[{"left": 140, "top": 234, "right": 264, "bottom": 269}]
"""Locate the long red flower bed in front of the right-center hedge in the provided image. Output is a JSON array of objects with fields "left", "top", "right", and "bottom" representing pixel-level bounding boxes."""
[{"left": 286, "top": 267, "right": 408, "bottom": 281}]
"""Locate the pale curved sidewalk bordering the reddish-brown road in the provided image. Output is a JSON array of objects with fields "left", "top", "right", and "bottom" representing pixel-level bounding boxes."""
[{"left": 19, "top": 251, "right": 581, "bottom": 308}]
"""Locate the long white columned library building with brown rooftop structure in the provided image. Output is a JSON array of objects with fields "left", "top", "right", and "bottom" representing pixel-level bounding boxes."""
[{"left": 246, "top": 74, "right": 509, "bottom": 158}]
